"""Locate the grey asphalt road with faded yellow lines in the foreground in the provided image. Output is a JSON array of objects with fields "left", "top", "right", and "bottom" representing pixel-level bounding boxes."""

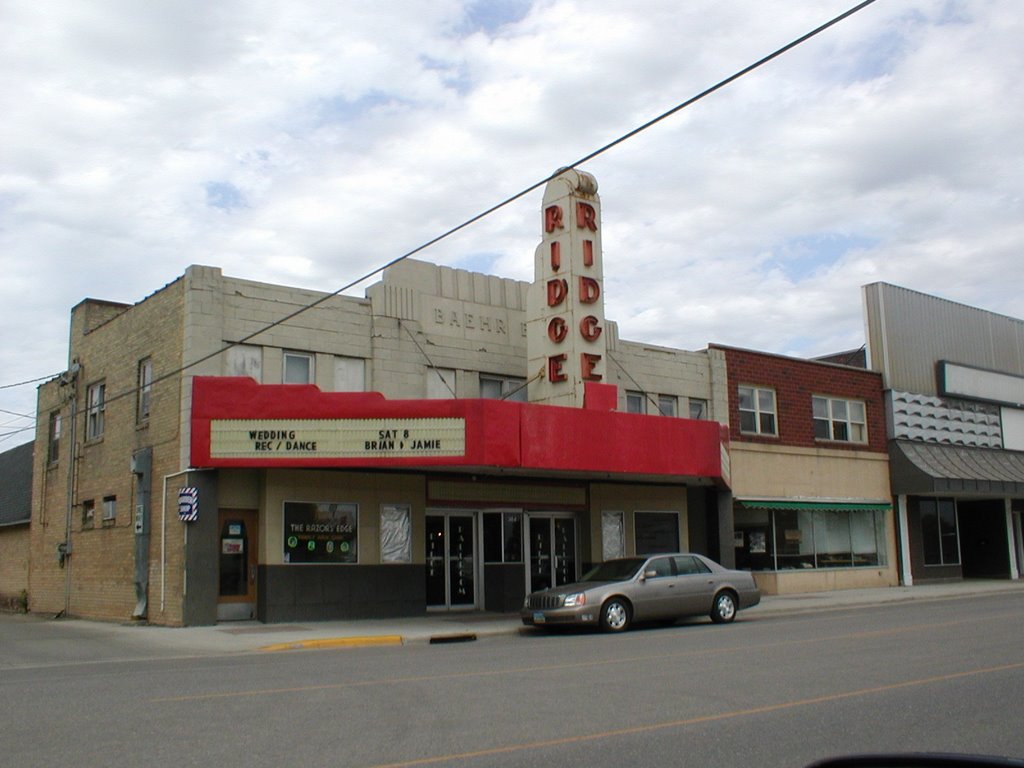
[{"left": 0, "top": 593, "right": 1024, "bottom": 768}]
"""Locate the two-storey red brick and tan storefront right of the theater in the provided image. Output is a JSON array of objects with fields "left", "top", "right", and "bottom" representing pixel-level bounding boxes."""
[{"left": 710, "top": 345, "right": 897, "bottom": 594}]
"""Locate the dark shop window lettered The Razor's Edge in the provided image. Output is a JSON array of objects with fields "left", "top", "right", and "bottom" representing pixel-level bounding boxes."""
[{"left": 285, "top": 502, "right": 359, "bottom": 563}]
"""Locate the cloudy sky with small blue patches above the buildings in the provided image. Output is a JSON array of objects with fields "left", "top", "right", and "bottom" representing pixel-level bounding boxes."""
[{"left": 0, "top": 0, "right": 1024, "bottom": 451}]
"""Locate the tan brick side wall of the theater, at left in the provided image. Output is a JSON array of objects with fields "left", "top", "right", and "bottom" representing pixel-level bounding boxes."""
[{"left": 30, "top": 281, "right": 188, "bottom": 624}]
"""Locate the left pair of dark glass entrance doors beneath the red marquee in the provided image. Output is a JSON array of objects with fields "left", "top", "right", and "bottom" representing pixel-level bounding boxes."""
[{"left": 426, "top": 512, "right": 476, "bottom": 610}]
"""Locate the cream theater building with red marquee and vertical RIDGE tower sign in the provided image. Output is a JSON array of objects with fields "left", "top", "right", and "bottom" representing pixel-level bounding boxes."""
[{"left": 30, "top": 171, "right": 736, "bottom": 625}]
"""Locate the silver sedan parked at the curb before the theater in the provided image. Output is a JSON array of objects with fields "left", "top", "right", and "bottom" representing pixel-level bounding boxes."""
[{"left": 520, "top": 553, "right": 761, "bottom": 632}]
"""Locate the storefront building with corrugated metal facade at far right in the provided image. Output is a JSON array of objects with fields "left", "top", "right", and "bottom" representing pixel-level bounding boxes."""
[{"left": 863, "top": 283, "right": 1024, "bottom": 585}]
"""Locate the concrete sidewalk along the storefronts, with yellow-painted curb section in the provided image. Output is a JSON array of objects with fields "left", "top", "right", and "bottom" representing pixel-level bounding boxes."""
[{"left": 8, "top": 580, "right": 1024, "bottom": 656}]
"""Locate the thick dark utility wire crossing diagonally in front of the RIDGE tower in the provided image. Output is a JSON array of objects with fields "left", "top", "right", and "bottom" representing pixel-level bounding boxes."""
[{"left": 9, "top": 0, "right": 876, "bottom": 421}]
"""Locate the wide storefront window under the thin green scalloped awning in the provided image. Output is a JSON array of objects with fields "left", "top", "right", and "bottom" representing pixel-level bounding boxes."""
[{"left": 735, "top": 508, "right": 886, "bottom": 570}]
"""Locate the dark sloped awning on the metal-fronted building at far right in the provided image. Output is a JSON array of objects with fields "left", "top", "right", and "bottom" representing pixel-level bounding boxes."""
[{"left": 889, "top": 440, "right": 1024, "bottom": 496}]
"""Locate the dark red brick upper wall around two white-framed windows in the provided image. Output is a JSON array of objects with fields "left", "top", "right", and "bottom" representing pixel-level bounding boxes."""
[{"left": 716, "top": 347, "right": 887, "bottom": 453}]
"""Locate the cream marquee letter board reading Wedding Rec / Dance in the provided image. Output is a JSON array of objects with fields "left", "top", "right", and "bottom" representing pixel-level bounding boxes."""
[{"left": 210, "top": 419, "right": 466, "bottom": 459}]
